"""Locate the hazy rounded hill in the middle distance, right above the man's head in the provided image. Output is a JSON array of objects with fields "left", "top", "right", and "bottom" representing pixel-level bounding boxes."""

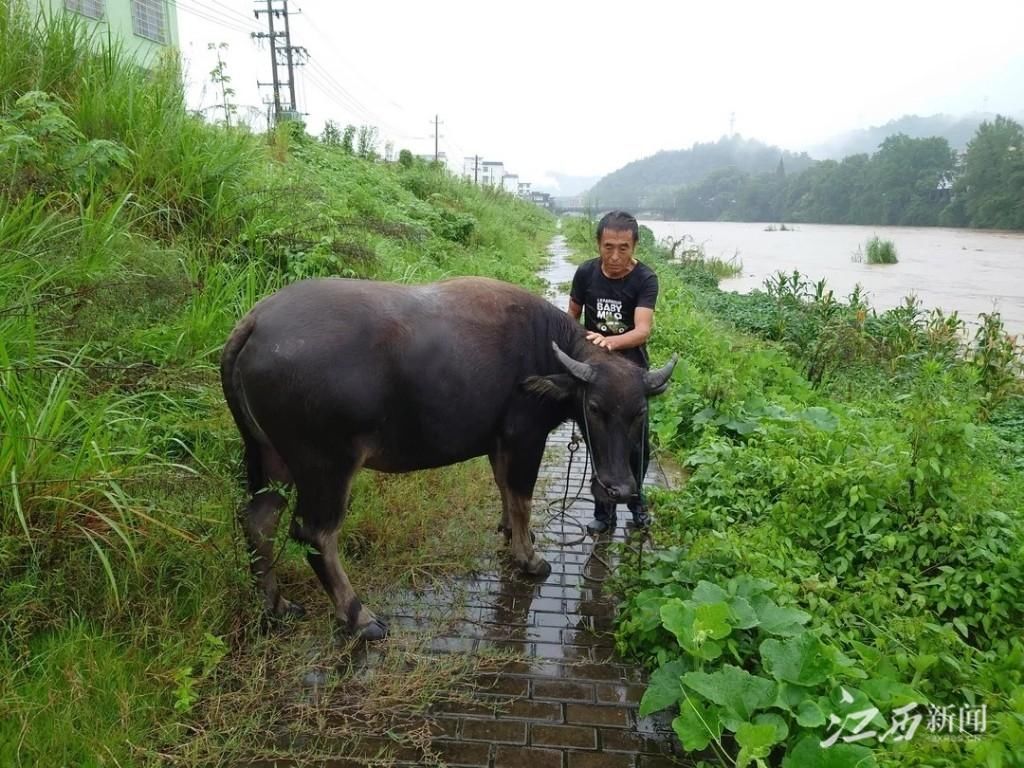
[{"left": 586, "top": 134, "right": 814, "bottom": 209}]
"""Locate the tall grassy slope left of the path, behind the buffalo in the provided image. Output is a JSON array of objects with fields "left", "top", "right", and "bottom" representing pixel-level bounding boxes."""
[{"left": 0, "top": 4, "right": 552, "bottom": 766}]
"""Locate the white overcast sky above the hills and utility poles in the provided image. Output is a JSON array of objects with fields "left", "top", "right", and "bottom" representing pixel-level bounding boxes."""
[{"left": 176, "top": 0, "right": 1024, "bottom": 192}]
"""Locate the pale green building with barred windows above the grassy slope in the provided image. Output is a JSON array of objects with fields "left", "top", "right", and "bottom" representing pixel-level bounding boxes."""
[{"left": 26, "top": 0, "right": 178, "bottom": 66}]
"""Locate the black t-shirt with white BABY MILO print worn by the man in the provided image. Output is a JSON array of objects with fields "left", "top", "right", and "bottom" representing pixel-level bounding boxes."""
[{"left": 569, "top": 258, "right": 657, "bottom": 368}]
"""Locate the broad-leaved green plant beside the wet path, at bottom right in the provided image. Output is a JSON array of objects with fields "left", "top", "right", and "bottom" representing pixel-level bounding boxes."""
[{"left": 618, "top": 577, "right": 905, "bottom": 768}]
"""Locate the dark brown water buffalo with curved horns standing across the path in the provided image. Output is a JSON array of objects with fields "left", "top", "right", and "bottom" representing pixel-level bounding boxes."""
[{"left": 220, "top": 278, "right": 675, "bottom": 640}]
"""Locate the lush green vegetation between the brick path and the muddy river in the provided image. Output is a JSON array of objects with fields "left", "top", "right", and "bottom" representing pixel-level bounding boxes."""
[{"left": 565, "top": 221, "right": 1024, "bottom": 768}]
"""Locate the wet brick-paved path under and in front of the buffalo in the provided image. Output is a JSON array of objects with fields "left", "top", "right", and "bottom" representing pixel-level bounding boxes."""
[{"left": 296, "top": 238, "right": 692, "bottom": 768}]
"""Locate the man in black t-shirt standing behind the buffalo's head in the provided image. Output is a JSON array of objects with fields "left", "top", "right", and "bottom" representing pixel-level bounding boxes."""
[{"left": 568, "top": 211, "right": 657, "bottom": 534}]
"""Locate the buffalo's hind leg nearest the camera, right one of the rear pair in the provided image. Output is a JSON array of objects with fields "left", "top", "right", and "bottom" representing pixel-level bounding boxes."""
[{"left": 292, "top": 468, "right": 387, "bottom": 640}]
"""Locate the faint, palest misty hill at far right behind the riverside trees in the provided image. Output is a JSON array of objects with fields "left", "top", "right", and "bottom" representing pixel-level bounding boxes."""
[{"left": 809, "top": 113, "right": 1015, "bottom": 160}]
